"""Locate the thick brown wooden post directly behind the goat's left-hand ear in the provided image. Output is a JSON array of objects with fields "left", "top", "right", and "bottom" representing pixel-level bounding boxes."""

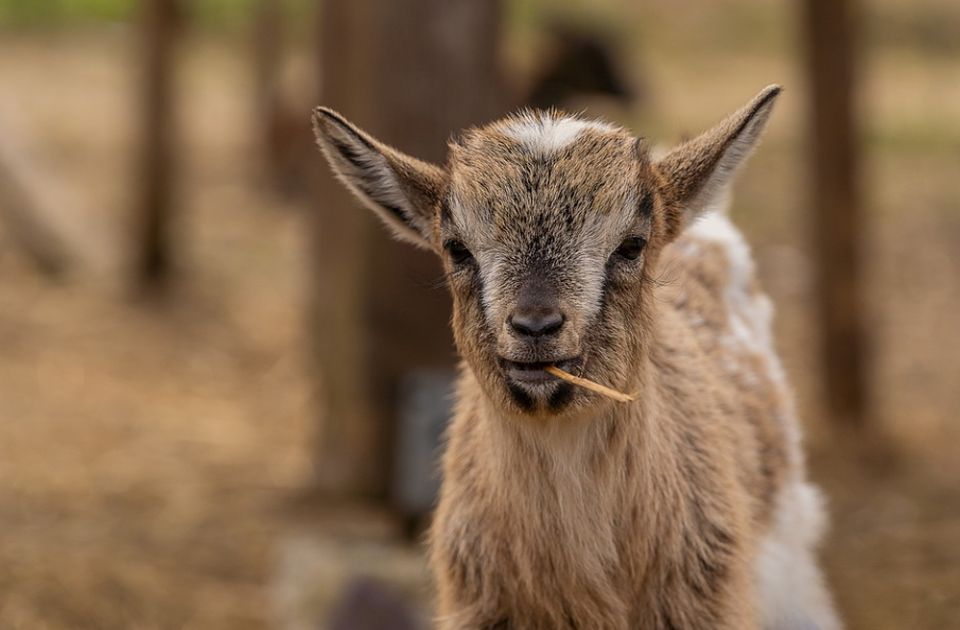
[{"left": 313, "top": 0, "right": 510, "bottom": 499}]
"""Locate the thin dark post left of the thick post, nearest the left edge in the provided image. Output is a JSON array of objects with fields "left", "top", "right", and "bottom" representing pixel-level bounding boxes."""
[{"left": 134, "top": 0, "right": 182, "bottom": 289}]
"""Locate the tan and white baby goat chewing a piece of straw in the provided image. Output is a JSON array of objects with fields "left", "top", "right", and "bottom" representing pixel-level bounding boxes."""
[{"left": 314, "top": 86, "right": 839, "bottom": 630}]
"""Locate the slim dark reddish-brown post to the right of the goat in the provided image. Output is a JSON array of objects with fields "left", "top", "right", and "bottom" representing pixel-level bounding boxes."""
[{"left": 804, "top": 0, "right": 867, "bottom": 428}]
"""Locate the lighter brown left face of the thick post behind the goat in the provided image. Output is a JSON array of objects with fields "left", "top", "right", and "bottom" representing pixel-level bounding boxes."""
[{"left": 304, "top": 0, "right": 386, "bottom": 498}]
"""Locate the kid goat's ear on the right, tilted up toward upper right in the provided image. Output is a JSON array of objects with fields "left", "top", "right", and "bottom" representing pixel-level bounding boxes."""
[{"left": 656, "top": 85, "right": 780, "bottom": 232}]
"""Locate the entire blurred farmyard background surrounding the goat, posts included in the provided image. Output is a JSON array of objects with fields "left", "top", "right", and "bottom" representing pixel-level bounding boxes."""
[{"left": 0, "top": 0, "right": 960, "bottom": 630}]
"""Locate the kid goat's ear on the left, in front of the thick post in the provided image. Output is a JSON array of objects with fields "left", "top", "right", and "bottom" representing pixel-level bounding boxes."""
[{"left": 313, "top": 107, "right": 447, "bottom": 249}]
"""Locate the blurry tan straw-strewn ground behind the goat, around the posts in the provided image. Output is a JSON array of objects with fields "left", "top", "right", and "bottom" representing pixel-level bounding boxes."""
[{"left": 0, "top": 17, "right": 960, "bottom": 630}]
